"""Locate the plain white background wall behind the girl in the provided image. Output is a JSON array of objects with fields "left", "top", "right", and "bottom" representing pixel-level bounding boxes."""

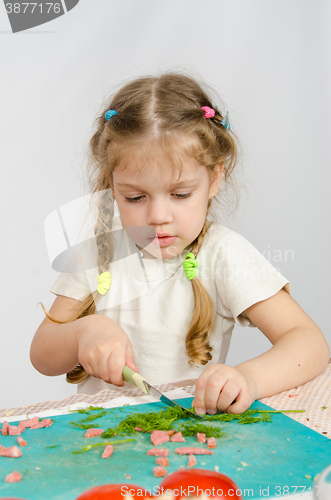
[{"left": 0, "top": 0, "right": 331, "bottom": 408}]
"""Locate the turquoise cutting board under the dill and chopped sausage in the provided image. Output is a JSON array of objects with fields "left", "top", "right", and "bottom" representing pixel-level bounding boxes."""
[{"left": 0, "top": 398, "right": 331, "bottom": 500}]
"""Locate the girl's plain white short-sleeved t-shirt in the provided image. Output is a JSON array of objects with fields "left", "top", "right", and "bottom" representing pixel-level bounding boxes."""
[{"left": 51, "top": 219, "right": 290, "bottom": 394}]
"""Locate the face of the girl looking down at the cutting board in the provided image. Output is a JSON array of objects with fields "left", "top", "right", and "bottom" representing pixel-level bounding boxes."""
[{"left": 112, "top": 148, "right": 222, "bottom": 259}]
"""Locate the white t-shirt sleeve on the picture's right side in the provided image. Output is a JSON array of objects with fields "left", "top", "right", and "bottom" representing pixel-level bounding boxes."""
[{"left": 215, "top": 232, "right": 290, "bottom": 326}]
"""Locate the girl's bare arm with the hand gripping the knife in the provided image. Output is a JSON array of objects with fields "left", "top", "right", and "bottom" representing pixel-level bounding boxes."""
[{"left": 30, "top": 295, "right": 137, "bottom": 386}]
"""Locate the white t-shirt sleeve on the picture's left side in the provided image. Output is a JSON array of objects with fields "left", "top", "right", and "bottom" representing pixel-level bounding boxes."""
[{"left": 50, "top": 247, "right": 91, "bottom": 301}]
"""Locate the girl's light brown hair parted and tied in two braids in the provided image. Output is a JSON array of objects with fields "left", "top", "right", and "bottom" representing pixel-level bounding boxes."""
[{"left": 46, "top": 73, "right": 237, "bottom": 383}]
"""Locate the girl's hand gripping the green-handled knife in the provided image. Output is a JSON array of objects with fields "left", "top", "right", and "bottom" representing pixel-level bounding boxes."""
[{"left": 77, "top": 314, "right": 138, "bottom": 387}]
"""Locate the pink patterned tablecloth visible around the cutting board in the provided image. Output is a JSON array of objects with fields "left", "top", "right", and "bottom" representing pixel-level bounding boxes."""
[{"left": 0, "top": 360, "right": 331, "bottom": 438}]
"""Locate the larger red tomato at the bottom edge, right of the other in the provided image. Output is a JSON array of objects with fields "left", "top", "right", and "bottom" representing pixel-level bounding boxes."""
[{"left": 159, "top": 469, "right": 242, "bottom": 500}]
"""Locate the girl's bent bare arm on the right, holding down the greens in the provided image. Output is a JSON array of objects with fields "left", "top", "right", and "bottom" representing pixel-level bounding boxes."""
[{"left": 194, "top": 290, "right": 330, "bottom": 413}]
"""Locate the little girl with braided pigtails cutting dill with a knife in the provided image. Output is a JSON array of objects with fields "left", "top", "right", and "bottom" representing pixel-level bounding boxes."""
[{"left": 31, "top": 74, "right": 329, "bottom": 414}]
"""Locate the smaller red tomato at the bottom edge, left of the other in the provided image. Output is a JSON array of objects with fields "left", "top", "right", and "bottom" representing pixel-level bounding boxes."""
[{"left": 76, "top": 484, "right": 154, "bottom": 500}]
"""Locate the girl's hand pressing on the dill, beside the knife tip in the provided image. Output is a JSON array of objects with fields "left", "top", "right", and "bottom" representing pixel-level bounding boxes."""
[{"left": 192, "top": 365, "right": 256, "bottom": 415}]
